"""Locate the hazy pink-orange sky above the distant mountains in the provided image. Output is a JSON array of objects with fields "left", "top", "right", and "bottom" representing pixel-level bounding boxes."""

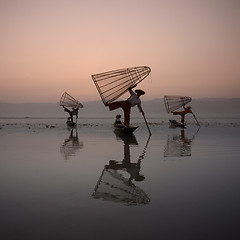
[{"left": 0, "top": 0, "right": 240, "bottom": 103}]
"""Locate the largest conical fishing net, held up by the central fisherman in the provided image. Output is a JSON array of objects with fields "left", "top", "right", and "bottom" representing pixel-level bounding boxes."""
[{"left": 92, "top": 66, "right": 151, "bottom": 105}]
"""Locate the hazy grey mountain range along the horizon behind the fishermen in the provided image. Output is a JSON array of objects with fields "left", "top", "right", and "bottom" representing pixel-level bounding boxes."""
[{"left": 0, "top": 98, "right": 240, "bottom": 118}]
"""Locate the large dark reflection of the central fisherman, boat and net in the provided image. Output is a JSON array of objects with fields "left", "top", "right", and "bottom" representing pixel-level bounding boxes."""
[{"left": 92, "top": 132, "right": 150, "bottom": 205}]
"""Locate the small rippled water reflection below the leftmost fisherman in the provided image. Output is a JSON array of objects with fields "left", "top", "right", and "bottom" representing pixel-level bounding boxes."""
[{"left": 60, "top": 128, "right": 83, "bottom": 160}]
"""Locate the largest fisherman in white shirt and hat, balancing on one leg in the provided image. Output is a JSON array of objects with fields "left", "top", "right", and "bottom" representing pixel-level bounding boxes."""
[{"left": 107, "top": 84, "right": 145, "bottom": 127}]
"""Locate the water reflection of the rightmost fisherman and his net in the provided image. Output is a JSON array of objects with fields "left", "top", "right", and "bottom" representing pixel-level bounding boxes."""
[{"left": 164, "top": 128, "right": 200, "bottom": 157}]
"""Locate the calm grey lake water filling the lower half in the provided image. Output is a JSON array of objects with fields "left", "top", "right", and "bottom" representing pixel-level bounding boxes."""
[{"left": 0, "top": 120, "right": 240, "bottom": 240}]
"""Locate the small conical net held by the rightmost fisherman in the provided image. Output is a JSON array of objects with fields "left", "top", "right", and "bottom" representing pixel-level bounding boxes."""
[{"left": 164, "top": 96, "right": 192, "bottom": 113}]
